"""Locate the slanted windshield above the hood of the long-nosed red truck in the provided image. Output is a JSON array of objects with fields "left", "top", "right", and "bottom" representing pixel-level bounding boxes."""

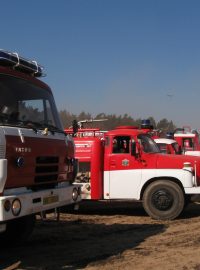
[{"left": 137, "top": 134, "right": 160, "bottom": 153}]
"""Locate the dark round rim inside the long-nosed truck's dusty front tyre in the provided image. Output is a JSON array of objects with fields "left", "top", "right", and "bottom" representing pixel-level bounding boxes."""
[{"left": 152, "top": 190, "right": 174, "bottom": 211}]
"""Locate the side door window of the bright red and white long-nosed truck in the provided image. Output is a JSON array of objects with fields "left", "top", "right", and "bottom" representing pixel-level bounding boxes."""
[{"left": 112, "top": 136, "right": 130, "bottom": 154}]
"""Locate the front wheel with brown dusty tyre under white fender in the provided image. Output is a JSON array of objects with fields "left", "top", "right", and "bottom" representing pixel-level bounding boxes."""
[{"left": 143, "top": 180, "right": 185, "bottom": 220}]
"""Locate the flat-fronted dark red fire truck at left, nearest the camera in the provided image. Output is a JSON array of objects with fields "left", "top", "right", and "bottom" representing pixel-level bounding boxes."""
[{"left": 0, "top": 50, "right": 80, "bottom": 240}]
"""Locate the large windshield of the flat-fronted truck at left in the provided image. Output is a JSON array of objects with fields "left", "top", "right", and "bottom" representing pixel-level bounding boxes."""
[{"left": 0, "top": 74, "right": 62, "bottom": 130}]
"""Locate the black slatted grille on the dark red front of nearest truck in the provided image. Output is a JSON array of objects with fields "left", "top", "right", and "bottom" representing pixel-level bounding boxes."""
[{"left": 34, "top": 156, "right": 59, "bottom": 184}]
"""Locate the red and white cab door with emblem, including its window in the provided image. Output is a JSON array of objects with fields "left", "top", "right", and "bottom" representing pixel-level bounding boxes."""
[{"left": 105, "top": 136, "right": 142, "bottom": 199}]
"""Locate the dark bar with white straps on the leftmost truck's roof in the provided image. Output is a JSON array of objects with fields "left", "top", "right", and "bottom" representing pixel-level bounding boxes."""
[{"left": 0, "top": 49, "right": 45, "bottom": 77}]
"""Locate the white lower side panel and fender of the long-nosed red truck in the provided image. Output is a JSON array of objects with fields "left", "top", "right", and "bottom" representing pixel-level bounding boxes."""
[{"left": 104, "top": 169, "right": 194, "bottom": 200}]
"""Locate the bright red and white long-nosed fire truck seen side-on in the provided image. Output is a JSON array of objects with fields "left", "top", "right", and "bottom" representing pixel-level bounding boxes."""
[{"left": 65, "top": 123, "right": 200, "bottom": 220}]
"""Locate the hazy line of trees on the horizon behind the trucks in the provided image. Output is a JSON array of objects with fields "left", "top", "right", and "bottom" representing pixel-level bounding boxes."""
[{"left": 59, "top": 110, "right": 176, "bottom": 132}]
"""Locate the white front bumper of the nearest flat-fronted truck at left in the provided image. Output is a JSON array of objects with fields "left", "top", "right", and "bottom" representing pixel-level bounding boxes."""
[{"left": 0, "top": 182, "right": 81, "bottom": 223}]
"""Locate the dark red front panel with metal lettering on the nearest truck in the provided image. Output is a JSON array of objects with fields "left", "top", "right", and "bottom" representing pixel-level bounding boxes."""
[{"left": 5, "top": 136, "right": 72, "bottom": 188}]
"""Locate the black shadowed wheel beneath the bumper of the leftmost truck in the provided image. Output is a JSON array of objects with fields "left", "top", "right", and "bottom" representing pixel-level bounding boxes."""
[{"left": 0, "top": 215, "right": 35, "bottom": 244}]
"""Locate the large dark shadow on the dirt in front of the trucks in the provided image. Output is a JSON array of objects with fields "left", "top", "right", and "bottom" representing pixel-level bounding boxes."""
[{"left": 0, "top": 219, "right": 166, "bottom": 270}]
